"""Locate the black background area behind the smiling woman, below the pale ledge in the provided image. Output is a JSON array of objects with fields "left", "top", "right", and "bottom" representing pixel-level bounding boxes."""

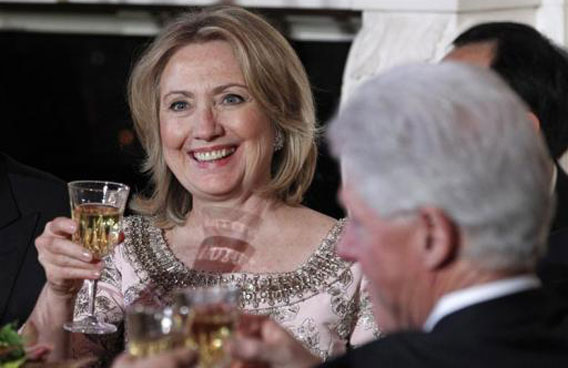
[{"left": 0, "top": 32, "right": 350, "bottom": 217}]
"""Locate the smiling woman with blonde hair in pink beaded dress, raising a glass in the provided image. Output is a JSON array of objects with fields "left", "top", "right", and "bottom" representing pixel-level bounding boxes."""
[{"left": 26, "top": 7, "right": 377, "bottom": 366}]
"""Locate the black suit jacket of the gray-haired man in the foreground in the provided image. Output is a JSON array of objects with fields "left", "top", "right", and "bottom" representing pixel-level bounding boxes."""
[{"left": 322, "top": 289, "right": 568, "bottom": 368}]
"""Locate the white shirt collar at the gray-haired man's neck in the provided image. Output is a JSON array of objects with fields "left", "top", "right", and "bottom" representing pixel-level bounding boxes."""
[{"left": 422, "top": 274, "right": 540, "bottom": 332}]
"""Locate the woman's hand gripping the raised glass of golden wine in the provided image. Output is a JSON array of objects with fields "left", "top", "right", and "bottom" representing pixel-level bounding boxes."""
[{"left": 35, "top": 217, "right": 102, "bottom": 298}]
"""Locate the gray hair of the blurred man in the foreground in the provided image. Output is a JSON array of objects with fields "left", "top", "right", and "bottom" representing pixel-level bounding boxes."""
[{"left": 328, "top": 62, "right": 554, "bottom": 270}]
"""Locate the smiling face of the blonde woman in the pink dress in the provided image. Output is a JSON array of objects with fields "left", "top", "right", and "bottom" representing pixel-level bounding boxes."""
[{"left": 160, "top": 41, "right": 277, "bottom": 200}]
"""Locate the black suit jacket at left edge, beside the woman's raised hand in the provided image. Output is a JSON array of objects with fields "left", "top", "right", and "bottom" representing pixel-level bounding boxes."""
[{"left": 0, "top": 153, "right": 70, "bottom": 325}]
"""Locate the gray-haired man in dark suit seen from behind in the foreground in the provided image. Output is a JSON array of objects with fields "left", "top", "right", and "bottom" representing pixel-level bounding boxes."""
[{"left": 226, "top": 62, "right": 568, "bottom": 368}]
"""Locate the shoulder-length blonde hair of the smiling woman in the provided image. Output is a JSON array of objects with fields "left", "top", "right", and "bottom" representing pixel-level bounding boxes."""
[{"left": 128, "top": 6, "right": 318, "bottom": 228}]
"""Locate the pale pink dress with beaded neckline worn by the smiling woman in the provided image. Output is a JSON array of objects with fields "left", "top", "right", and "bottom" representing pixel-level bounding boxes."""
[{"left": 73, "top": 216, "right": 380, "bottom": 365}]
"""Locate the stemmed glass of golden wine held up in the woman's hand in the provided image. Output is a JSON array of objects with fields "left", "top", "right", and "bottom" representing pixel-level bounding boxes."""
[{"left": 63, "top": 181, "right": 130, "bottom": 335}]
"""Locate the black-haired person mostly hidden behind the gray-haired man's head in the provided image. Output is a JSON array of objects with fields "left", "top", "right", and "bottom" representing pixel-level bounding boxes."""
[{"left": 444, "top": 22, "right": 568, "bottom": 297}]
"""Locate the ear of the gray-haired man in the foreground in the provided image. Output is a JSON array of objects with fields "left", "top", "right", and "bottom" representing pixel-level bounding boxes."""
[{"left": 419, "top": 207, "right": 459, "bottom": 270}]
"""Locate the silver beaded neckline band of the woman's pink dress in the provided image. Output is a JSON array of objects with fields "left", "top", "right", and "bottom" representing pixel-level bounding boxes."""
[{"left": 122, "top": 216, "right": 351, "bottom": 309}]
